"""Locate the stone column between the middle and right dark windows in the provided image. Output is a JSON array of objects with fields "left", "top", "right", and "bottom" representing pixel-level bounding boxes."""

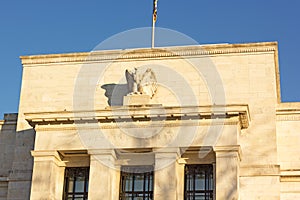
[{"left": 154, "top": 148, "right": 180, "bottom": 200}]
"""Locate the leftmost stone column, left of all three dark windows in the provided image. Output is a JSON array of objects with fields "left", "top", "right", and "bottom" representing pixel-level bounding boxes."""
[{"left": 30, "top": 151, "right": 65, "bottom": 200}]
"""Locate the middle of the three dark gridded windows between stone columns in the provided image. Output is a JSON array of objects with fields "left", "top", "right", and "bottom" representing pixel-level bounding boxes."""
[{"left": 120, "top": 166, "right": 153, "bottom": 200}]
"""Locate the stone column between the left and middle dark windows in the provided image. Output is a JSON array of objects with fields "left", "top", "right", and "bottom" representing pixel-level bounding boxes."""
[{"left": 88, "top": 150, "right": 120, "bottom": 200}]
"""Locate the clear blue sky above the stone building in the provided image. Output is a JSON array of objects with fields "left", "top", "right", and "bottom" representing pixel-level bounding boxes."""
[{"left": 0, "top": 0, "right": 300, "bottom": 116}]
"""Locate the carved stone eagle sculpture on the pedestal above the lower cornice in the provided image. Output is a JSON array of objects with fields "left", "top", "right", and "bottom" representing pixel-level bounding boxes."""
[{"left": 125, "top": 68, "right": 157, "bottom": 98}]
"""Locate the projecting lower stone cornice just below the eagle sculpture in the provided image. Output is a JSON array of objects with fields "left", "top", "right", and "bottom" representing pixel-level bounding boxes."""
[{"left": 24, "top": 104, "right": 250, "bottom": 129}]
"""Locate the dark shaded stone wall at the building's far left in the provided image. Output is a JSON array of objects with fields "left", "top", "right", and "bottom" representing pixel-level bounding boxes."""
[{"left": 0, "top": 113, "right": 35, "bottom": 199}]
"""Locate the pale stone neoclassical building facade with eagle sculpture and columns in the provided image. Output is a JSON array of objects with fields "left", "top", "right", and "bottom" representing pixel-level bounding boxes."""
[{"left": 0, "top": 42, "right": 300, "bottom": 200}]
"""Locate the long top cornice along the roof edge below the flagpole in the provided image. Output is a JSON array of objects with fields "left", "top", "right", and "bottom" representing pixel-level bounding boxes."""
[{"left": 20, "top": 42, "right": 277, "bottom": 66}]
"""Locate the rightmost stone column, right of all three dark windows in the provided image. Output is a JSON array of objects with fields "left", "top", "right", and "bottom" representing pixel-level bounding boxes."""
[{"left": 214, "top": 146, "right": 241, "bottom": 200}]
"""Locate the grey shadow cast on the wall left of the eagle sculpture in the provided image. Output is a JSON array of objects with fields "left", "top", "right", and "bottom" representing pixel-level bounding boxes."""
[{"left": 101, "top": 83, "right": 129, "bottom": 106}]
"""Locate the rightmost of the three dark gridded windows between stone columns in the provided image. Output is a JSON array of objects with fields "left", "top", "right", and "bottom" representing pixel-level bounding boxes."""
[{"left": 184, "top": 165, "right": 214, "bottom": 200}]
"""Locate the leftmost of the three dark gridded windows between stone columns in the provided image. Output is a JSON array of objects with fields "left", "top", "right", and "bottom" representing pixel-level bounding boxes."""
[{"left": 64, "top": 167, "right": 89, "bottom": 200}]
